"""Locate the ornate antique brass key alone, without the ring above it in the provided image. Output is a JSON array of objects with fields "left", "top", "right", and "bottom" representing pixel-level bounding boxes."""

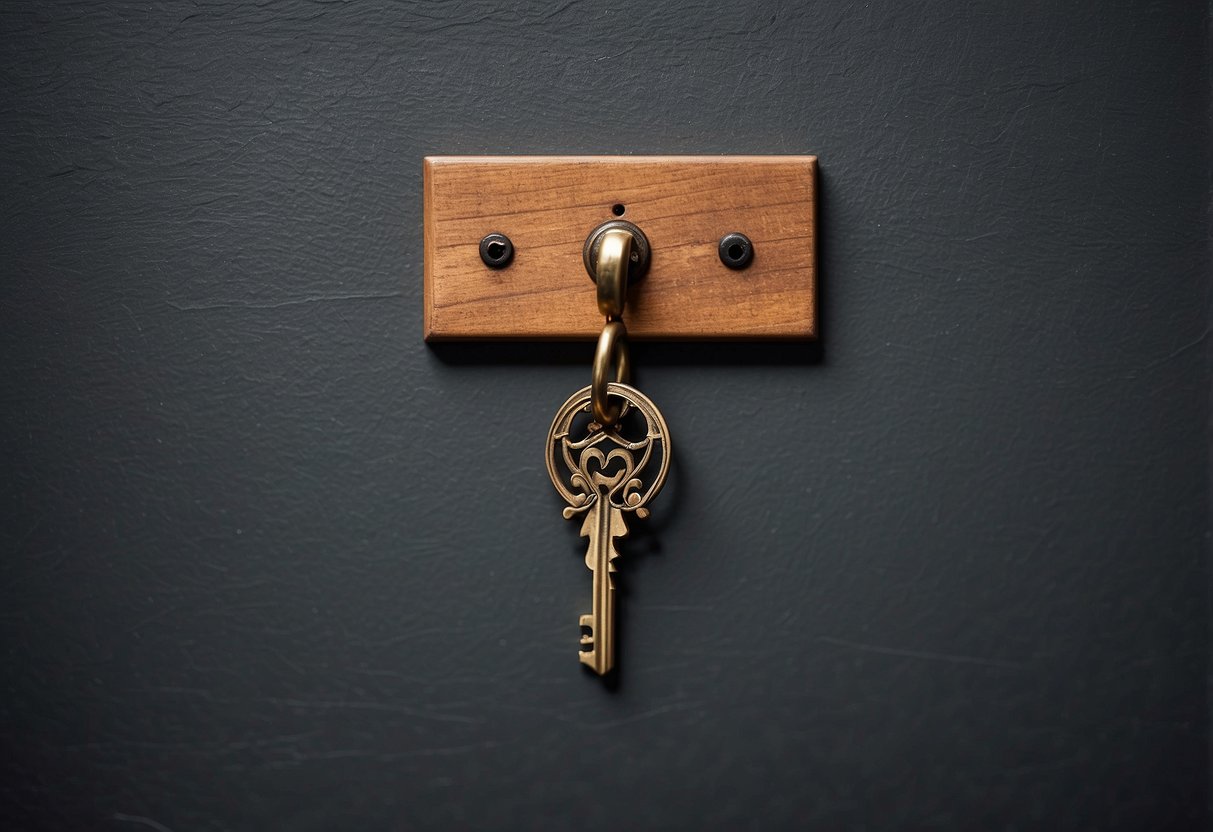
[{"left": 547, "top": 383, "right": 670, "bottom": 676}]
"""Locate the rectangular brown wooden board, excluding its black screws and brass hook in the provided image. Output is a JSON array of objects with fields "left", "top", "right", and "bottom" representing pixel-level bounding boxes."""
[{"left": 425, "top": 156, "right": 816, "bottom": 341}]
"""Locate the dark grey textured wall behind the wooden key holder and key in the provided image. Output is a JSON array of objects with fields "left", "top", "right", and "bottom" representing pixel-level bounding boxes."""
[{"left": 0, "top": 0, "right": 1211, "bottom": 832}]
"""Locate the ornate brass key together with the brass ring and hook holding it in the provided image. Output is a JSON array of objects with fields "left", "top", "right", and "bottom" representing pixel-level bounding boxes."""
[{"left": 547, "top": 229, "right": 670, "bottom": 676}]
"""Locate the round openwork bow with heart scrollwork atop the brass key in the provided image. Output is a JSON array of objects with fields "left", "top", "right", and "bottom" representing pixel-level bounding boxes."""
[{"left": 547, "top": 383, "right": 670, "bottom": 519}]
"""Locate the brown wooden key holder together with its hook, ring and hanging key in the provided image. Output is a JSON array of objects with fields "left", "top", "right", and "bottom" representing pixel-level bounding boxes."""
[{"left": 425, "top": 156, "right": 818, "bottom": 676}]
